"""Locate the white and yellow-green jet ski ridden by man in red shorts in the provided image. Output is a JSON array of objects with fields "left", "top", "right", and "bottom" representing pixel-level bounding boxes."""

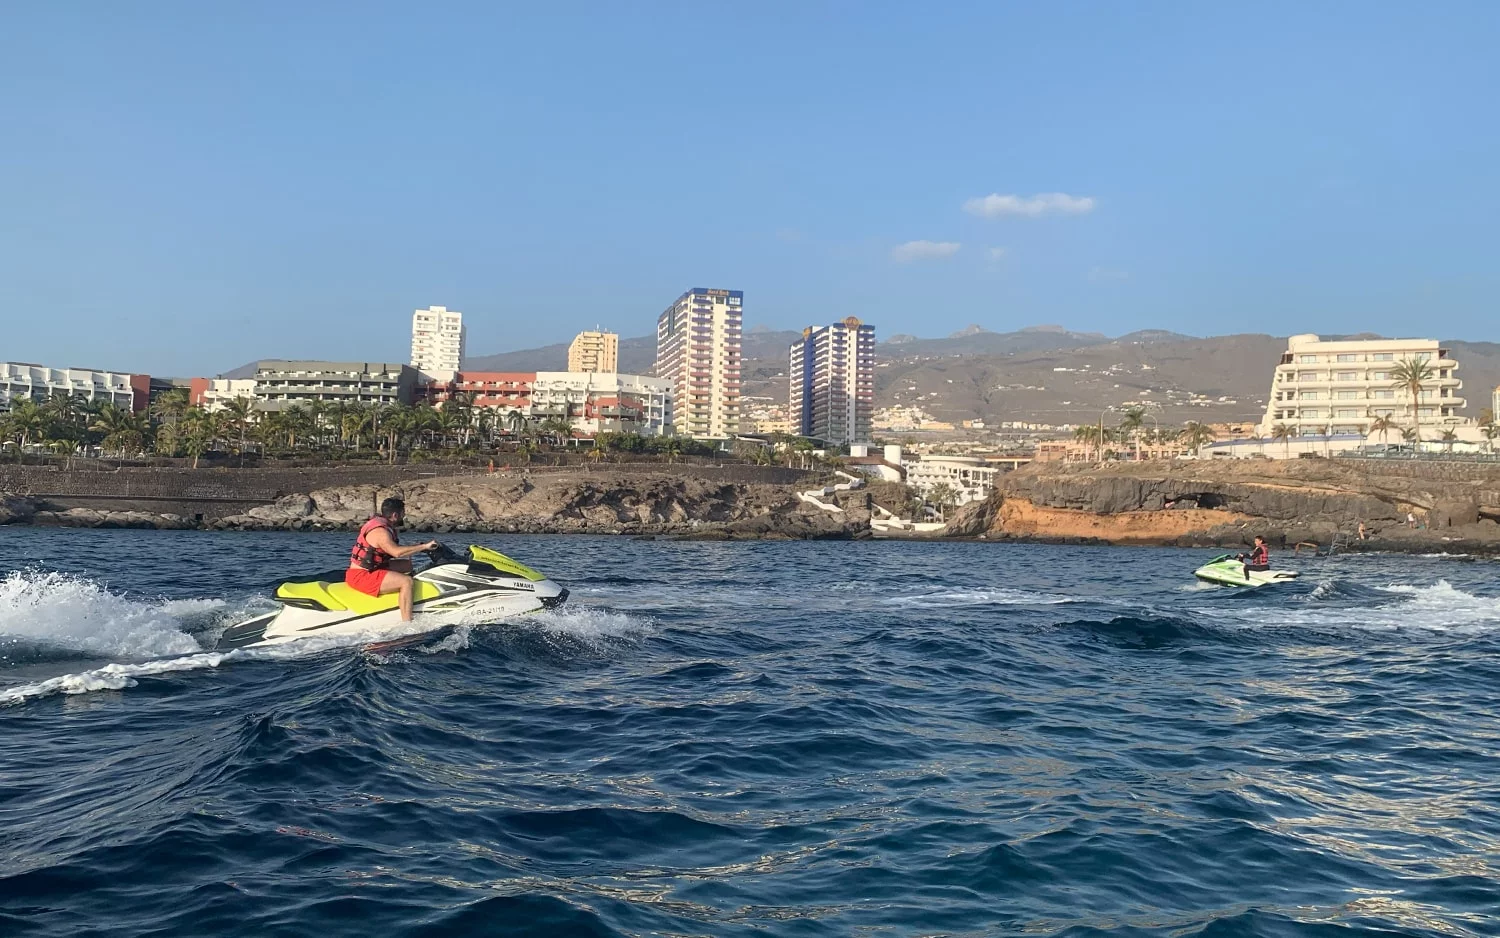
[{"left": 216, "top": 545, "right": 567, "bottom": 651}]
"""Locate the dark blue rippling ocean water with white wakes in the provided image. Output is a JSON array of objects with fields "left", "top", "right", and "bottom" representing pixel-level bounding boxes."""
[{"left": 0, "top": 528, "right": 1500, "bottom": 938}]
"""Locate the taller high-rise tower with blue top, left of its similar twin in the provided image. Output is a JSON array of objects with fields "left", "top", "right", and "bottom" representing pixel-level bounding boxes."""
[{"left": 654, "top": 287, "right": 744, "bottom": 440}]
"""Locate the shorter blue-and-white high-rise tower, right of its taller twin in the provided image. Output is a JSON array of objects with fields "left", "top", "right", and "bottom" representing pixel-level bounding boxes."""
[{"left": 788, "top": 317, "right": 875, "bottom": 443}]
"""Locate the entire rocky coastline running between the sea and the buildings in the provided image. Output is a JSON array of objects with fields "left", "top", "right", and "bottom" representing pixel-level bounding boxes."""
[{"left": 0, "top": 459, "right": 1500, "bottom": 557}]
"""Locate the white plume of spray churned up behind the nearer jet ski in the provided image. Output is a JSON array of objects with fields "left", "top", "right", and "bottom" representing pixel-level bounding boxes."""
[{"left": 0, "top": 570, "right": 213, "bottom": 657}]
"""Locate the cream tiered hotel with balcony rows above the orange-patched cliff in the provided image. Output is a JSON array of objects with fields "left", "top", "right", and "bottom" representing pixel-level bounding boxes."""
[{"left": 1257, "top": 335, "right": 1464, "bottom": 441}]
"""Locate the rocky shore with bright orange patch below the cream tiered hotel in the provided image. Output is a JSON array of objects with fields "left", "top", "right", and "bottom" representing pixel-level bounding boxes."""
[{"left": 948, "top": 459, "right": 1500, "bottom": 554}]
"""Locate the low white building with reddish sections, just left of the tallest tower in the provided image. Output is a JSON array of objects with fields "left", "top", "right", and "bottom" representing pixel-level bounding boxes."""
[{"left": 530, "top": 371, "right": 672, "bottom": 437}]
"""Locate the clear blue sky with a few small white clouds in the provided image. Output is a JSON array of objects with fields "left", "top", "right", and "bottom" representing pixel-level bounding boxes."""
[{"left": 0, "top": 0, "right": 1500, "bottom": 377}]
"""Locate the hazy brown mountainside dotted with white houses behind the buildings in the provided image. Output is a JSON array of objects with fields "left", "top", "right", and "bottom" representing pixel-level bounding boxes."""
[{"left": 217, "top": 326, "right": 1500, "bottom": 426}]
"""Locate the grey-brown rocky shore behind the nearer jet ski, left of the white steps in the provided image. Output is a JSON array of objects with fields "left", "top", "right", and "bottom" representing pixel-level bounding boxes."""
[{"left": 0, "top": 470, "right": 870, "bottom": 539}]
